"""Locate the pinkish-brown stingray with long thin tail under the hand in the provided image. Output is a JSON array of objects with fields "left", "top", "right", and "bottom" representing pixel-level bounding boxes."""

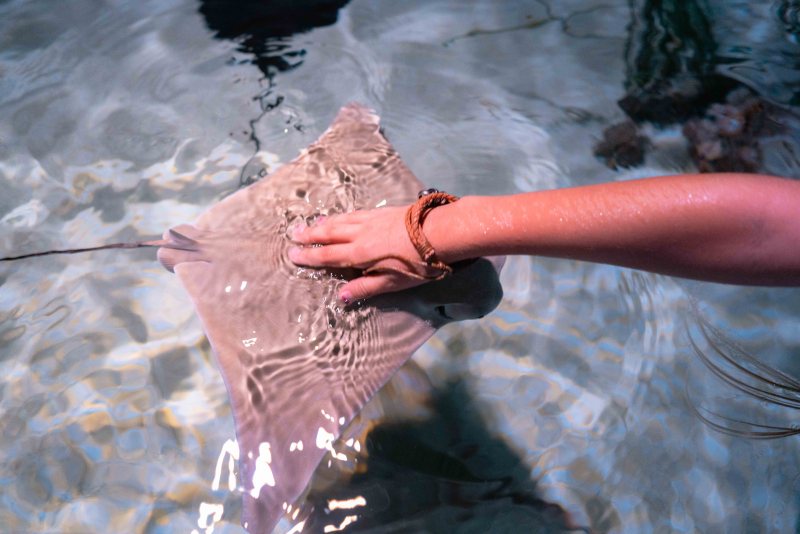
[{"left": 4, "top": 104, "right": 503, "bottom": 533}]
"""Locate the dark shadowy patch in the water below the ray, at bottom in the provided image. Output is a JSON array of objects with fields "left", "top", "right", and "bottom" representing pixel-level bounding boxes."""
[{"left": 306, "top": 383, "right": 580, "bottom": 532}]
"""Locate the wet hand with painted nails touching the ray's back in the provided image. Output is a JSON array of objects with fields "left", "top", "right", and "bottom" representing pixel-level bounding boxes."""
[{"left": 289, "top": 207, "right": 425, "bottom": 303}]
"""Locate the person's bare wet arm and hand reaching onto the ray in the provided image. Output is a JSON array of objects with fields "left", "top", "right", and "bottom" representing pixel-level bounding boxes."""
[{"left": 290, "top": 174, "right": 800, "bottom": 299}]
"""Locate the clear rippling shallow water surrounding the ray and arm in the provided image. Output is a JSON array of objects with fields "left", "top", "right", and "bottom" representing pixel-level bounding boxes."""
[{"left": 0, "top": 0, "right": 800, "bottom": 532}]
